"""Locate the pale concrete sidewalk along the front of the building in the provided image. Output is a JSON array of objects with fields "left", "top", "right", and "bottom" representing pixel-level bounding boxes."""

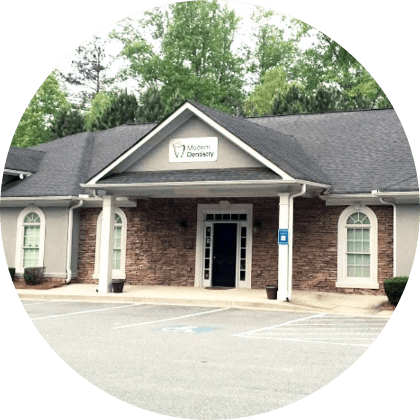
[{"left": 13, "top": 284, "right": 393, "bottom": 318}]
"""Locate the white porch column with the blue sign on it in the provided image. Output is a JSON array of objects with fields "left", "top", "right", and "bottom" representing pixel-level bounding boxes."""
[{"left": 277, "top": 193, "right": 290, "bottom": 301}]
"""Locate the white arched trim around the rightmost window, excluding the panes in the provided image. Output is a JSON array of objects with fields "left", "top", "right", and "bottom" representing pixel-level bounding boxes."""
[{"left": 335, "top": 206, "right": 379, "bottom": 289}]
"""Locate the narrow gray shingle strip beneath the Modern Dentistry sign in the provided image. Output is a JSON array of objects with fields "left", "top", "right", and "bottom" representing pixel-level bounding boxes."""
[{"left": 99, "top": 168, "right": 281, "bottom": 184}]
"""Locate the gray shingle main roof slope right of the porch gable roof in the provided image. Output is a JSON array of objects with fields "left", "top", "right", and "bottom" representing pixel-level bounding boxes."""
[{"left": 252, "top": 109, "right": 418, "bottom": 193}]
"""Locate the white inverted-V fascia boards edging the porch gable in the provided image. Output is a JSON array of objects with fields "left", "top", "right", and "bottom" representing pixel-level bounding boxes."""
[{"left": 85, "top": 102, "right": 293, "bottom": 187}]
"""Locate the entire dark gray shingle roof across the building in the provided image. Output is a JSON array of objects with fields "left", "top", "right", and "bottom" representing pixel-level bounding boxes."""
[{"left": 2, "top": 103, "right": 418, "bottom": 197}]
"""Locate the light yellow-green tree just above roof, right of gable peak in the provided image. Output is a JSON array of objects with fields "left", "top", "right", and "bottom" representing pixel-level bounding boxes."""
[{"left": 244, "top": 67, "right": 288, "bottom": 116}]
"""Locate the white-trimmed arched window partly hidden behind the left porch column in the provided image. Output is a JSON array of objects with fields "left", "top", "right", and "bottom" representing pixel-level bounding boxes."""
[{"left": 93, "top": 209, "right": 127, "bottom": 279}]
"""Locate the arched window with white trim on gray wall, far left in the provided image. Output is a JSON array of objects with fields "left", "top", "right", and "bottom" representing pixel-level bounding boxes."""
[{"left": 15, "top": 207, "right": 45, "bottom": 274}]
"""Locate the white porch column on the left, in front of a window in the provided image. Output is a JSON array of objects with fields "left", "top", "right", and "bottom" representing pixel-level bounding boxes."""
[{"left": 98, "top": 195, "right": 115, "bottom": 293}]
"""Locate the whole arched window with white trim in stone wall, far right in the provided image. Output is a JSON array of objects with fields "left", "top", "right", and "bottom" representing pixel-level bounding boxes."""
[{"left": 336, "top": 206, "right": 379, "bottom": 289}]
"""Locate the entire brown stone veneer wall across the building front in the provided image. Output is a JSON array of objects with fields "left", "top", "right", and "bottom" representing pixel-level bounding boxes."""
[{"left": 74, "top": 198, "right": 393, "bottom": 294}]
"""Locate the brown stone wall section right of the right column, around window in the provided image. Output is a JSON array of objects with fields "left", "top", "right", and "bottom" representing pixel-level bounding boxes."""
[{"left": 292, "top": 198, "right": 393, "bottom": 294}]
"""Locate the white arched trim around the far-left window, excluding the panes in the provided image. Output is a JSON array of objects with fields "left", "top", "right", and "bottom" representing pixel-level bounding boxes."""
[{"left": 15, "top": 206, "right": 46, "bottom": 276}]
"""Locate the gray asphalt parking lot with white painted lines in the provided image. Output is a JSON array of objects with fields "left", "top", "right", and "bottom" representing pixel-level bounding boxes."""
[{"left": 22, "top": 299, "right": 388, "bottom": 420}]
